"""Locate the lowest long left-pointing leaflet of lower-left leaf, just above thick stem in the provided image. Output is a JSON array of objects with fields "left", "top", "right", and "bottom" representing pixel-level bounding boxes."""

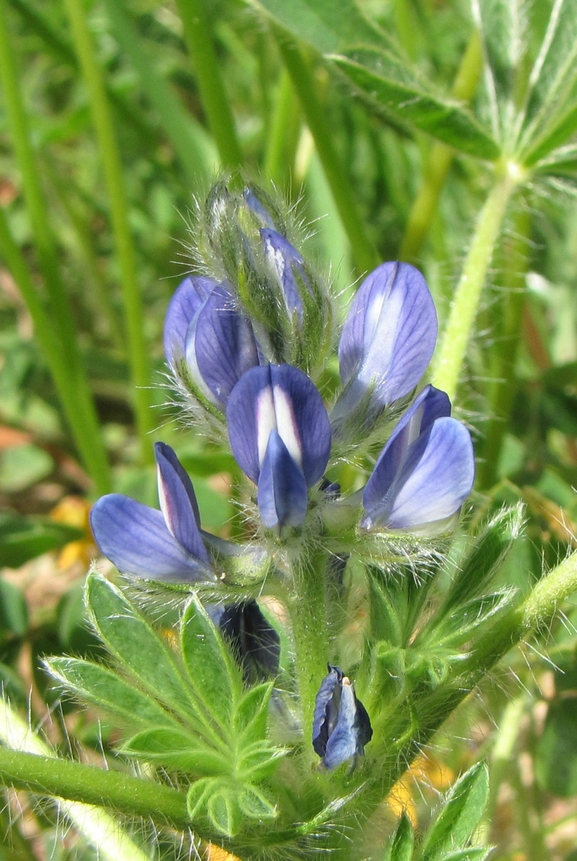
[{"left": 120, "top": 727, "right": 232, "bottom": 777}]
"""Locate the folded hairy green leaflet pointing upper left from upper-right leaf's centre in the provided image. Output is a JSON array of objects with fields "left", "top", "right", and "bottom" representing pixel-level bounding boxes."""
[{"left": 328, "top": 50, "right": 501, "bottom": 161}]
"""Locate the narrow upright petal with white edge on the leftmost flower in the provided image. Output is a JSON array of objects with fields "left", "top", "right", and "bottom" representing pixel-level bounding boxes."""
[{"left": 154, "top": 442, "right": 209, "bottom": 564}]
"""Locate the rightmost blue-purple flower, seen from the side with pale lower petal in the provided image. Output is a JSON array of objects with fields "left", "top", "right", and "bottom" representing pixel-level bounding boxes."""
[{"left": 361, "top": 386, "right": 475, "bottom": 531}]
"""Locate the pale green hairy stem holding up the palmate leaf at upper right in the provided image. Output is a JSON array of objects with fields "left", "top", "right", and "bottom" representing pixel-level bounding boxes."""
[{"left": 432, "top": 162, "right": 523, "bottom": 400}]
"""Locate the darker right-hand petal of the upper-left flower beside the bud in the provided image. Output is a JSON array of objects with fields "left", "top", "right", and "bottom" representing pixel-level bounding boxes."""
[{"left": 187, "top": 287, "right": 259, "bottom": 407}]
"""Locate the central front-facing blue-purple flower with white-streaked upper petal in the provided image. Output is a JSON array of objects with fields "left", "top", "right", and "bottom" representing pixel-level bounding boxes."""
[{"left": 226, "top": 365, "right": 331, "bottom": 529}]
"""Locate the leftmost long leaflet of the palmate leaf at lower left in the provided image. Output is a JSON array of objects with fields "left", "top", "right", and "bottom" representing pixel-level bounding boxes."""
[{"left": 45, "top": 657, "right": 177, "bottom": 727}]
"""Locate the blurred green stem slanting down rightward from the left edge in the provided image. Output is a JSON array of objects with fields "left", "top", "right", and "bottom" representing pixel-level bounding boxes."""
[{"left": 0, "top": 207, "right": 111, "bottom": 494}]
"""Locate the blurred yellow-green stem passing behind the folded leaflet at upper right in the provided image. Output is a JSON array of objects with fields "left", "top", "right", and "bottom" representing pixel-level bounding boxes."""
[{"left": 399, "top": 30, "right": 483, "bottom": 263}]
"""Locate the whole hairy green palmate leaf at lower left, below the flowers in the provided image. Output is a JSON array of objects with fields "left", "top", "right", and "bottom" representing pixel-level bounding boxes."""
[{"left": 45, "top": 574, "right": 284, "bottom": 836}]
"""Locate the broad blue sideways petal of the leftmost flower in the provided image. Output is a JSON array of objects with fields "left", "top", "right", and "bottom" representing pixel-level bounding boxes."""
[{"left": 90, "top": 493, "right": 215, "bottom": 582}]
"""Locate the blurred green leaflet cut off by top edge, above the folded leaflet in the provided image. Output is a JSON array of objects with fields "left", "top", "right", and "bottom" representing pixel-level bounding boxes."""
[{"left": 245, "top": 0, "right": 395, "bottom": 54}]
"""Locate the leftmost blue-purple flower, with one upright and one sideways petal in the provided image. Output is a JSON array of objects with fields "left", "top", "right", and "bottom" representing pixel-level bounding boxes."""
[{"left": 90, "top": 442, "right": 215, "bottom": 582}]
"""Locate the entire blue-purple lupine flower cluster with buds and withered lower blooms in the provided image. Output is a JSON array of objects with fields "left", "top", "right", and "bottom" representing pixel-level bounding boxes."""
[{"left": 92, "top": 184, "right": 474, "bottom": 768}]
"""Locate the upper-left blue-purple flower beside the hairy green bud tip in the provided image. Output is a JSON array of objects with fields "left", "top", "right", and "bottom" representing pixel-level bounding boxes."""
[{"left": 164, "top": 278, "right": 259, "bottom": 410}]
